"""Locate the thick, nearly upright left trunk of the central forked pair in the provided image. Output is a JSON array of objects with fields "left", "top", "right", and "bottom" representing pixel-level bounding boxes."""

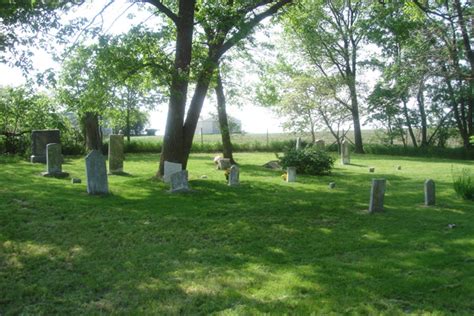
[{"left": 157, "top": 0, "right": 196, "bottom": 177}]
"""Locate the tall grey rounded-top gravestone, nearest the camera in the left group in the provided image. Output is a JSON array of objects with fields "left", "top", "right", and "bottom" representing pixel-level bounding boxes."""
[{"left": 86, "top": 150, "right": 109, "bottom": 194}]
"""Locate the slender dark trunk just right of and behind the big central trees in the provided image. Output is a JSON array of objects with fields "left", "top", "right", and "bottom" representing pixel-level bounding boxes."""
[{"left": 215, "top": 67, "right": 236, "bottom": 164}]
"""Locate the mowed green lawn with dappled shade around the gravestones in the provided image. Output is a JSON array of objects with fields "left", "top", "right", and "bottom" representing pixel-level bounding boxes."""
[{"left": 0, "top": 153, "right": 474, "bottom": 315}]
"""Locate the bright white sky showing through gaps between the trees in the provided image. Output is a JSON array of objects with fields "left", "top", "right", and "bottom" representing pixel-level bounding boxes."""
[{"left": 0, "top": 0, "right": 283, "bottom": 134}]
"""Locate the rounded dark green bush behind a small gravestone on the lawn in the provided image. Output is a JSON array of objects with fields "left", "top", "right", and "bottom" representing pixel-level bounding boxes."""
[{"left": 277, "top": 147, "right": 335, "bottom": 175}]
